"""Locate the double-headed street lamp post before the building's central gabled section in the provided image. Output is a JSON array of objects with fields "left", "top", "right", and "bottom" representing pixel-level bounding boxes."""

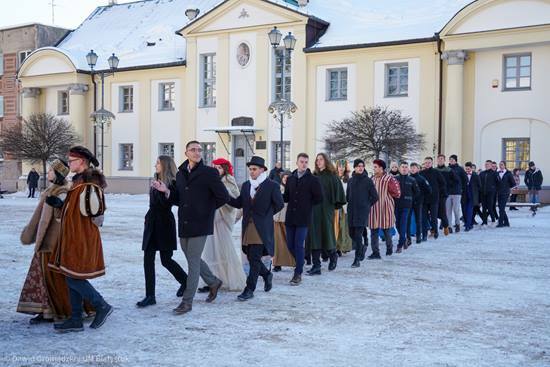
[{"left": 268, "top": 27, "right": 298, "bottom": 169}]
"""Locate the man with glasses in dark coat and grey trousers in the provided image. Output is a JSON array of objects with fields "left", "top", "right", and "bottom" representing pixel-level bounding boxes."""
[{"left": 153, "top": 140, "right": 230, "bottom": 314}]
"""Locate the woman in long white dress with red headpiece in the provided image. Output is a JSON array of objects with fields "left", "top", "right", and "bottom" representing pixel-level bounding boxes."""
[{"left": 199, "top": 158, "right": 246, "bottom": 292}]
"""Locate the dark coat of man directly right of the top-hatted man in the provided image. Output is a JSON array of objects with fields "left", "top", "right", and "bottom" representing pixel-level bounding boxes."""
[{"left": 283, "top": 169, "right": 323, "bottom": 227}]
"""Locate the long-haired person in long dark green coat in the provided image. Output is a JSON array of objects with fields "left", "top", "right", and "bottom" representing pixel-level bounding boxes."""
[{"left": 306, "top": 153, "right": 346, "bottom": 275}]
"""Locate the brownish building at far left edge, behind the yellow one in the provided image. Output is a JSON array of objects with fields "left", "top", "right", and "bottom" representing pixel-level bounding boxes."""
[{"left": 0, "top": 24, "right": 68, "bottom": 191}]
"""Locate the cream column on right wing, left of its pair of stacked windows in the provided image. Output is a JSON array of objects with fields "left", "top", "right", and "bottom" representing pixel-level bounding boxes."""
[{"left": 441, "top": 50, "right": 467, "bottom": 159}]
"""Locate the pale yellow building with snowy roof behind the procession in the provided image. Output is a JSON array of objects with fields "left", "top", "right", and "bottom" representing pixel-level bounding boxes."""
[{"left": 15, "top": 0, "right": 550, "bottom": 200}]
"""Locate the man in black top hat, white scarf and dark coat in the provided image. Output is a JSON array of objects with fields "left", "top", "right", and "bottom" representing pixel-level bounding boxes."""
[{"left": 229, "top": 156, "right": 285, "bottom": 301}]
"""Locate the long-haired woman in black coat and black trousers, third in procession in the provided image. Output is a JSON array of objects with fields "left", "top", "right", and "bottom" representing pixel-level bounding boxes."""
[{"left": 136, "top": 155, "right": 187, "bottom": 307}]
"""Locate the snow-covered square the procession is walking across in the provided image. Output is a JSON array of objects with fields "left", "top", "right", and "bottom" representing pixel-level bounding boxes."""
[{"left": 0, "top": 194, "right": 550, "bottom": 367}]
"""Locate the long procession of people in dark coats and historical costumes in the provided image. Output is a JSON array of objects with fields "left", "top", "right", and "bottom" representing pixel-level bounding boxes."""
[{"left": 18, "top": 141, "right": 542, "bottom": 332}]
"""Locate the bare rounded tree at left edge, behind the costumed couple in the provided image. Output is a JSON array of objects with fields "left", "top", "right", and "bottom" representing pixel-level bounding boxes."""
[{"left": 0, "top": 113, "right": 80, "bottom": 188}]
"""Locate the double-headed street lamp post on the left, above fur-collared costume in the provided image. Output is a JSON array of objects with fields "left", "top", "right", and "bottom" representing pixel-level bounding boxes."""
[{"left": 86, "top": 50, "right": 119, "bottom": 169}]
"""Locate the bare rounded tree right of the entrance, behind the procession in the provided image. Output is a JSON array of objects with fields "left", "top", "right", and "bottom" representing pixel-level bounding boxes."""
[{"left": 325, "top": 106, "right": 426, "bottom": 160}]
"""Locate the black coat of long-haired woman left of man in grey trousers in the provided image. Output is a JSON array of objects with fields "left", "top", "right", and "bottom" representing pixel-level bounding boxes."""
[{"left": 141, "top": 181, "right": 178, "bottom": 251}]
